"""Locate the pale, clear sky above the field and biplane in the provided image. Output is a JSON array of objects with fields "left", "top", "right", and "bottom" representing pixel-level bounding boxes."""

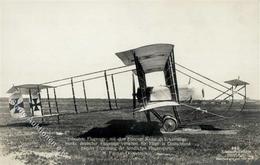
[{"left": 0, "top": 0, "right": 260, "bottom": 99}]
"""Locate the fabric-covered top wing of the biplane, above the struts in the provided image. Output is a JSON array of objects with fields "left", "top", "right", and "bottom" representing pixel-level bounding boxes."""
[{"left": 116, "top": 44, "right": 174, "bottom": 73}]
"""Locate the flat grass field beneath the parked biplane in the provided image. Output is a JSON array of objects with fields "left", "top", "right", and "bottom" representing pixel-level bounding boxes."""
[{"left": 0, "top": 98, "right": 260, "bottom": 164}]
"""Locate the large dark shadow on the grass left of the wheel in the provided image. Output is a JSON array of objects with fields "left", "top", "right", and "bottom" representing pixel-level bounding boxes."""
[{"left": 76, "top": 120, "right": 162, "bottom": 139}]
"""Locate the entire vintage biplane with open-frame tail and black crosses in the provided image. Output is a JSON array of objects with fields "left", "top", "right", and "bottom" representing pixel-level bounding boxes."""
[{"left": 7, "top": 44, "right": 249, "bottom": 132}]
